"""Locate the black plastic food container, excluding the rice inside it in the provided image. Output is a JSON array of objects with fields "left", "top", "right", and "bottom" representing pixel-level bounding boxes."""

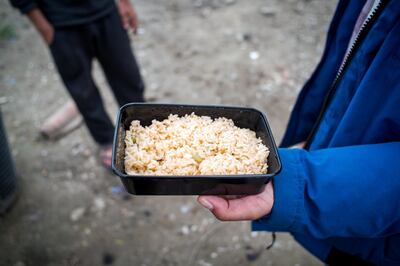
[{"left": 112, "top": 103, "right": 281, "bottom": 195}]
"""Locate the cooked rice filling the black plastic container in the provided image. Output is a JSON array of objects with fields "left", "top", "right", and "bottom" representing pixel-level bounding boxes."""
[{"left": 125, "top": 113, "right": 269, "bottom": 175}]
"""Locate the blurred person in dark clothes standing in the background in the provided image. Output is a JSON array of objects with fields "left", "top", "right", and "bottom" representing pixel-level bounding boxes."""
[{"left": 10, "top": 0, "right": 144, "bottom": 168}]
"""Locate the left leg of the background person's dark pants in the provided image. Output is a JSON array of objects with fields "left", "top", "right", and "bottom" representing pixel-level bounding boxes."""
[{"left": 50, "top": 26, "right": 114, "bottom": 145}]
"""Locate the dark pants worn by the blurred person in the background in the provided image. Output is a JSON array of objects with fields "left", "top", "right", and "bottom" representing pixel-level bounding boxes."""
[{"left": 50, "top": 9, "right": 144, "bottom": 145}]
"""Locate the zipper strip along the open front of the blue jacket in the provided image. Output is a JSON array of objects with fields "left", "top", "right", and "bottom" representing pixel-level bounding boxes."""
[{"left": 304, "top": 0, "right": 388, "bottom": 150}]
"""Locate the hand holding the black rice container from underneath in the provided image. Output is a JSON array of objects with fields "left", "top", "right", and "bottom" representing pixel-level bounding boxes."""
[{"left": 197, "top": 182, "right": 274, "bottom": 221}]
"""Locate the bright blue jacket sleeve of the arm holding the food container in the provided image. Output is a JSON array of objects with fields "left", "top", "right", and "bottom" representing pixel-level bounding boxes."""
[{"left": 253, "top": 142, "right": 400, "bottom": 239}]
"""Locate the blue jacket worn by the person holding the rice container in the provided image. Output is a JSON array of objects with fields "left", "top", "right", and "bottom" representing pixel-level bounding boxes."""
[{"left": 253, "top": 0, "right": 400, "bottom": 265}]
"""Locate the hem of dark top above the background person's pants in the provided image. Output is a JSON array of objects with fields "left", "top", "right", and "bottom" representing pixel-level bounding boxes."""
[{"left": 10, "top": 0, "right": 115, "bottom": 27}]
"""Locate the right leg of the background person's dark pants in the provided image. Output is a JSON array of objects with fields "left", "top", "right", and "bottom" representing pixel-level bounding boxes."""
[{"left": 92, "top": 10, "right": 144, "bottom": 106}]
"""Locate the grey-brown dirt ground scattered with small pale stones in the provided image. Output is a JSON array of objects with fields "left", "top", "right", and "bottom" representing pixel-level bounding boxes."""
[{"left": 0, "top": 0, "right": 335, "bottom": 266}]
